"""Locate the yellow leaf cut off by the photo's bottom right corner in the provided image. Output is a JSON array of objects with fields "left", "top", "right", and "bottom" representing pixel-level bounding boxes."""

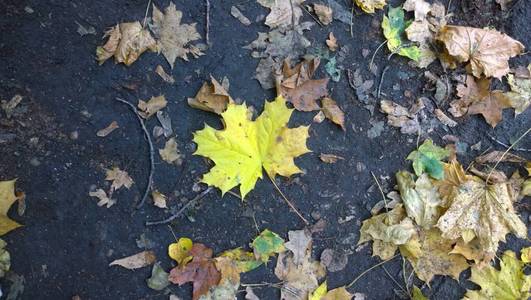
[{"left": 463, "top": 250, "right": 531, "bottom": 299}]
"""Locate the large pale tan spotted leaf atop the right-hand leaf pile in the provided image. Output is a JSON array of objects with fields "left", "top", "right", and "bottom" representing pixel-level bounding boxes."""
[{"left": 437, "top": 178, "right": 527, "bottom": 254}]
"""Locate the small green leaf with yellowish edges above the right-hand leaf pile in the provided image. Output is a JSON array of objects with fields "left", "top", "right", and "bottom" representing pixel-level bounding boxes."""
[{"left": 407, "top": 139, "right": 450, "bottom": 180}]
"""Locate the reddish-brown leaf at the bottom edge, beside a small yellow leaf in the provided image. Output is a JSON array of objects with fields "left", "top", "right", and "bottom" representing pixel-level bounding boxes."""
[{"left": 168, "top": 243, "right": 221, "bottom": 300}]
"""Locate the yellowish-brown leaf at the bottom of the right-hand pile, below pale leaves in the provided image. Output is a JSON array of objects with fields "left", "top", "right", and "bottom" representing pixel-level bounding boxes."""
[{"left": 400, "top": 228, "right": 469, "bottom": 284}]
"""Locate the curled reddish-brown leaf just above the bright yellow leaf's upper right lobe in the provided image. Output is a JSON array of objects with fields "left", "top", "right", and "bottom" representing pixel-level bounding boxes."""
[{"left": 277, "top": 58, "right": 328, "bottom": 110}]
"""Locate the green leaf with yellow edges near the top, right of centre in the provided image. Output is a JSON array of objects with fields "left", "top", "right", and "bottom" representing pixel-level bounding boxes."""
[{"left": 382, "top": 7, "right": 420, "bottom": 61}]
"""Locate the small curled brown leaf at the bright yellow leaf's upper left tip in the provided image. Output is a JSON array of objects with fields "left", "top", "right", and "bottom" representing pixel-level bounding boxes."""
[{"left": 188, "top": 76, "right": 234, "bottom": 115}]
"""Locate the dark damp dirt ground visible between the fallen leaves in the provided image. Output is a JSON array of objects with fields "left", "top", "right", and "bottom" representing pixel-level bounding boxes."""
[{"left": 0, "top": 0, "right": 531, "bottom": 299}]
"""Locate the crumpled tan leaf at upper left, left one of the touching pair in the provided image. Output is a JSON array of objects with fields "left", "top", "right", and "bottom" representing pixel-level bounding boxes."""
[{"left": 96, "top": 21, "right": 157, "bottom": 66}]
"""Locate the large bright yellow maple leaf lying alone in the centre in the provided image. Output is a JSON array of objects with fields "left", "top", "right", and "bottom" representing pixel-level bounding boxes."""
[{"left": 194, "top": 96, "right": 310, "bottom": 198}]
